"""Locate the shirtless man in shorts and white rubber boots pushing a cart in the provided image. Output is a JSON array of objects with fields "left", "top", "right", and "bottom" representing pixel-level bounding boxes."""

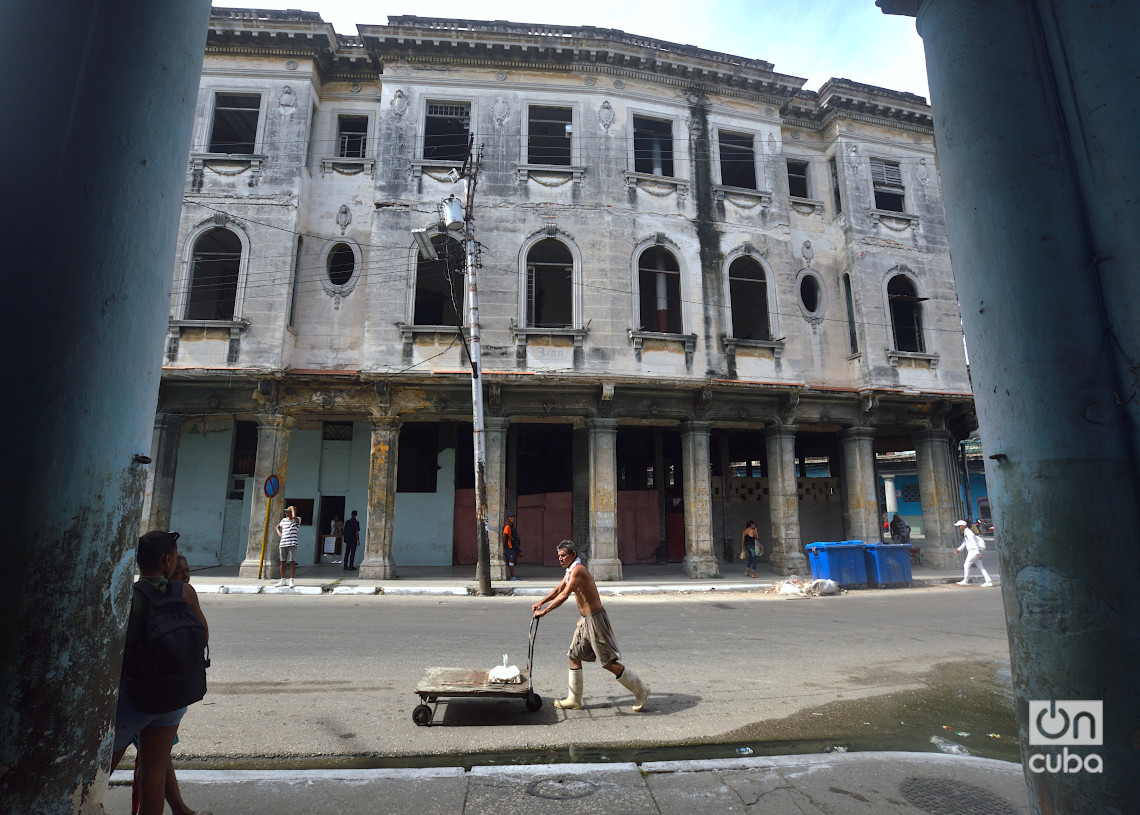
[{"left": 530, "top": 540, "right": 650, "bottom": 712}]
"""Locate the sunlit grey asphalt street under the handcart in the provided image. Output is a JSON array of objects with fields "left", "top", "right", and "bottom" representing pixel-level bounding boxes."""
[{"left": 176, "top": 586, "right": 1016, "bottom": 766}]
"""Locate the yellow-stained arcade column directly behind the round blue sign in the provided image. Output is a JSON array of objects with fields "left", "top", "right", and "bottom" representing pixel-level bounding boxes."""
[{"left": 237, "top": 414, "right": 293, "bottom": 579}]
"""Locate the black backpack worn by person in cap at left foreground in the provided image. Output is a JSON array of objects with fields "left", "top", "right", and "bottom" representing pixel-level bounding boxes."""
[{"left": 123, "top": 580, "right": 210, "bottom": 714}]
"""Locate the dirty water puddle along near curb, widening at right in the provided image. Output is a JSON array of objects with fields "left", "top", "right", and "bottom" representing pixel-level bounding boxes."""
[{"left": 178, "top": 661, "right": 1021, "bottom": 769}]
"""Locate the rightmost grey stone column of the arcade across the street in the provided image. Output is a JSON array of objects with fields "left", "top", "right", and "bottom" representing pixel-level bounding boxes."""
[{"left": 914, "top": 430, "right": 960, "bottom": 569}]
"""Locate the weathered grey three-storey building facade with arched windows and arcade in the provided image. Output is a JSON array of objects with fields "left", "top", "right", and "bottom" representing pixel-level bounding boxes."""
[{"left": 144, "top": 9, "right": 972, "bottom": 579}]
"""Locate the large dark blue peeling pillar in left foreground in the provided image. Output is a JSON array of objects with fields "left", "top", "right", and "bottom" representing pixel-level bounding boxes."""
[{"left": 0, "top": 0, "right": 210, "bottom": 815}]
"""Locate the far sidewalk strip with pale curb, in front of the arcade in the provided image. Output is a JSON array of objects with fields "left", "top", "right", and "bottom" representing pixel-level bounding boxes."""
[{"left": 184, "top": 559, "right": 1000, "bottom": 597}]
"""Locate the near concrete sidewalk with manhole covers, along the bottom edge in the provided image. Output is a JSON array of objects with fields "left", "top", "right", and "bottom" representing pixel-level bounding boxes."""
[{"left": 105, "top": 752, "right": 1029, "bottom": 815}]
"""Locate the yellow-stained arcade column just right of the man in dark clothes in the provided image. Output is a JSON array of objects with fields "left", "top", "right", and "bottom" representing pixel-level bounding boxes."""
[{"left": 359, "top": 416, "right": 400, "bottom": 580}]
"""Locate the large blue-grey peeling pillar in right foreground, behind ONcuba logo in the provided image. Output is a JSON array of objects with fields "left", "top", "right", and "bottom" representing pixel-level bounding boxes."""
[{"left": 880, "top": 0, "right": 1140, "bottom": 813}]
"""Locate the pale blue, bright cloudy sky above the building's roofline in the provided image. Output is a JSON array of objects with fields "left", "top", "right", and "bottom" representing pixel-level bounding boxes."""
[{"left": 214, "top": 0, "right": 928, "bottom": 97}]
